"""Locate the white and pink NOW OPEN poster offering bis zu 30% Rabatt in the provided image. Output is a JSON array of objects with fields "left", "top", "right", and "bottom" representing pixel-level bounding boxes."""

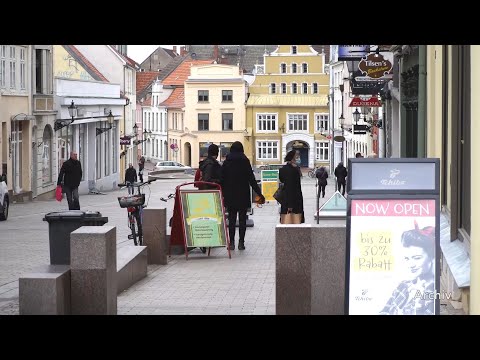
[{"left": 347, "top": 196, "right": 438, "bottom": 315}]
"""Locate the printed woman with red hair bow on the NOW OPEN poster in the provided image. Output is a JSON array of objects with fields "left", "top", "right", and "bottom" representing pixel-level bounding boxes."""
[{"left": 380, "top": 222, "right": 435, "bottom": 315}]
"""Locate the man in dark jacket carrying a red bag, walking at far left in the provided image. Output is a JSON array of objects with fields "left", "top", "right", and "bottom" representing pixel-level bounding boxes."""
[{"left": 57, "top": 151, "right": 82, "bottom": 210}]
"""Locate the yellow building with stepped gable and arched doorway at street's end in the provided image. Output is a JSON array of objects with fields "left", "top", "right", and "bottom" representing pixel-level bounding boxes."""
[{"left": 244, "top": 45, "right": 330, "bottom": 168}]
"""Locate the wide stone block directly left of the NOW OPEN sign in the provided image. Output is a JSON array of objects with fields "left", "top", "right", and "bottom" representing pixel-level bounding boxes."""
[{"left": 275, "top": 222, "right": 346, "bottom": 315}]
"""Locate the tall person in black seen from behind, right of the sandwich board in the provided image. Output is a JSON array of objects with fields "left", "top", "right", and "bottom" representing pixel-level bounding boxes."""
[{"left": 221, "top": 141, "right": 265, "bottom": 250}]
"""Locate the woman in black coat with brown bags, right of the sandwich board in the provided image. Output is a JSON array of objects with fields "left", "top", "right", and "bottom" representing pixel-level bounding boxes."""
[{"left": 279, "top": 150, "right": 305, "bottom": 223}]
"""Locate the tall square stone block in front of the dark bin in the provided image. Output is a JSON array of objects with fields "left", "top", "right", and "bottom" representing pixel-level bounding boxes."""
[{"left": 70, "top": 225, "right": 117, "bottom": 315}]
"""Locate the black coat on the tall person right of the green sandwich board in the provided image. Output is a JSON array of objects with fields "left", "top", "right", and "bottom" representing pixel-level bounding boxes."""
[{"left": 221, "top": 152, "right": 262, "bottom": 210}]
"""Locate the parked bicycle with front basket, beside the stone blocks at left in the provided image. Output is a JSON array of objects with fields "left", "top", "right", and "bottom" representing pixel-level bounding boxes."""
[{"left": 118, "top": 179, "right": 156, "bottom": 246}]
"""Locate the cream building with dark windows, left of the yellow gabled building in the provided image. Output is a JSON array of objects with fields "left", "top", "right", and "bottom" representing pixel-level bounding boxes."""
[{"left": 169, "top": 64, "right": 246, "bottom": 167}]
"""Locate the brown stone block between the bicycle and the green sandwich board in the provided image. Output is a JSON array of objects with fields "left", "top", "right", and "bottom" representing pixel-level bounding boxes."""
[{"left": 142, "top": 209, "right": 168, "bottom": 265}]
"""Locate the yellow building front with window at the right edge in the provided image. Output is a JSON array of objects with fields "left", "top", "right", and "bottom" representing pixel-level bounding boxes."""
[{"left": 425, "top": 45, "right": 480, "bottom": 314}]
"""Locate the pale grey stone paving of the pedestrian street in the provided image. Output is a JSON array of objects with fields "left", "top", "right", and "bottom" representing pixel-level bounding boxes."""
[{"left": 0, "top": 168, "right": 463, "bottom": 315}]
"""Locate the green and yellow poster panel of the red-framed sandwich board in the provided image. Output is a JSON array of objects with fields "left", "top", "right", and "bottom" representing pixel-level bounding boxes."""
[{"left": 180, "top": 190, "right": 227, "bottom": 247}]
